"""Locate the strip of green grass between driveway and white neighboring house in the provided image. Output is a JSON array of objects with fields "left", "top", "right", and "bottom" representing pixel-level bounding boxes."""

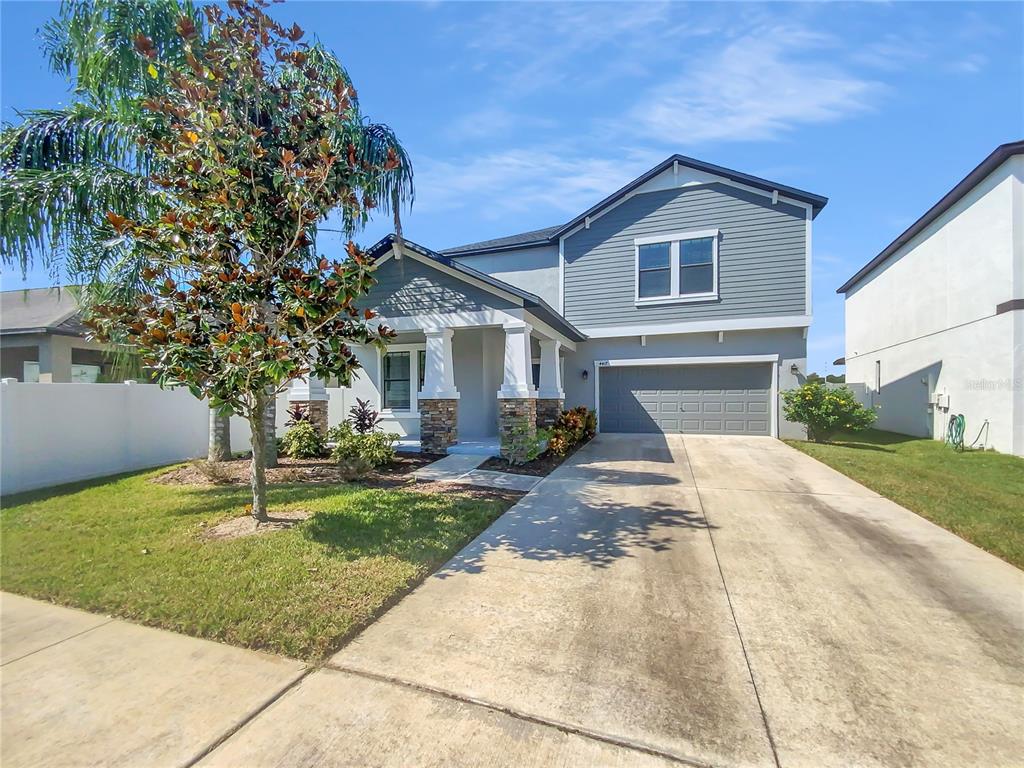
[{"left": 787, "top": 429, "right": 1024, "bottom": 568}]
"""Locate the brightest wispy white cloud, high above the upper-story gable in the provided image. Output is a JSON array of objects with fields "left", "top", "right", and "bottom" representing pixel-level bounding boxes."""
[{"left": 630, "top": 27, "right": 883, "bottom": 145}]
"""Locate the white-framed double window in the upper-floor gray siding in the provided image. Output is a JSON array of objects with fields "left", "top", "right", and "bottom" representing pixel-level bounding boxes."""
[{"left": 634, "top": 229, "right": 718, "bottom": 304}]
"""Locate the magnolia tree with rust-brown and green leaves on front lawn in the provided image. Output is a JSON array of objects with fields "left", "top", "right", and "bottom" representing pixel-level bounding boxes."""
[{"left": 89, "top": 0, "right": 401, "bottom": 521}]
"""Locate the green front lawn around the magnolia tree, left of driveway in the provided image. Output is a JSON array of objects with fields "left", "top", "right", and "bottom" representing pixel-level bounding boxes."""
[{"left": 0, "top": 470, "right": 509, "bottom": 659}]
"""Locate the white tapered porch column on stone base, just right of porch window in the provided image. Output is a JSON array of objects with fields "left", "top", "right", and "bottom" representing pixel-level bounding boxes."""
[{"left": 418, "top": 328, "right": 459, "bottom": 454}]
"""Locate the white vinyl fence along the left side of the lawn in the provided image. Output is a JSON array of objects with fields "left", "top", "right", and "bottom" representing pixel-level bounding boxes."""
[{"left": 0, "top": 380, "right": 264, "bottom": 495}]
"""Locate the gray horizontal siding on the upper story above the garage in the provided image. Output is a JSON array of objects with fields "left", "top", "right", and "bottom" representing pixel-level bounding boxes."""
[{"left": 564, "top": 184, "right": 806, "bottom": 330}]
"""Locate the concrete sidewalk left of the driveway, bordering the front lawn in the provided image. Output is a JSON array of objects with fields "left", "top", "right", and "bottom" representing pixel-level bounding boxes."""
[{"left": 0, "top": 593, "right": 305, "bottom": 768}]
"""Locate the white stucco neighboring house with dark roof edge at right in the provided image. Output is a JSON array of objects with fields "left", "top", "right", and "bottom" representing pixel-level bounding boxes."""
[{"left": 838, "top": 141, "right": 1024, "bottom": 456}]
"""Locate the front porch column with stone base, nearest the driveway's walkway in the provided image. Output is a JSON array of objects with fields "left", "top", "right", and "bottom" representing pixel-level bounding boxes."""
[{"left": 498, "top": 323, "right": 537, "bottom": 464}]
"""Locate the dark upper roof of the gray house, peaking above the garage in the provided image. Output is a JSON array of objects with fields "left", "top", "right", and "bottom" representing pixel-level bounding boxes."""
[{"left": 441, "top": 155, "right": 828, "bottom": 256}]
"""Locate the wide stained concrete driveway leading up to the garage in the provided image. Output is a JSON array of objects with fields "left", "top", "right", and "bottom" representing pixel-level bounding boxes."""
[{"left": 201, "top": 435, "right": 1024, "bottom": 768}]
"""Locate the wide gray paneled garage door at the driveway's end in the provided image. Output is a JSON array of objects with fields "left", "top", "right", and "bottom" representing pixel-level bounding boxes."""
[{"left": 598, "top": 364, "right": 771, "bottom": 434}]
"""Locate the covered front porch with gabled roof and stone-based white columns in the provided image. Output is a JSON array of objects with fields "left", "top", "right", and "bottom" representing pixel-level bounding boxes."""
[{"left": 291, "top": 241, "right": 585, "bottom": 454}]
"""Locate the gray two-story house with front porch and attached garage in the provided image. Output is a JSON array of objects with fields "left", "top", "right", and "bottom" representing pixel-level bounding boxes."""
[{"left": 293, "top": 155, "right": 827, "bottom": 452}]
